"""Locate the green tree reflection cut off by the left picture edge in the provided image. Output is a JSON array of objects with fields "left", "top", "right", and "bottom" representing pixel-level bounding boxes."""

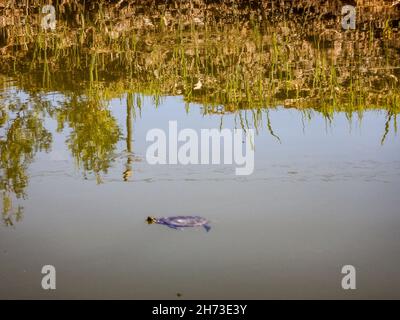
[{"left": 0, "top": 102, "right": 52, "bottom": 226}]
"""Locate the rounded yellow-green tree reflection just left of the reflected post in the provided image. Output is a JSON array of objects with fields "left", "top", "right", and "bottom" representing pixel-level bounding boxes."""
[{"left": 57, "top": 96, "right": 120, "bottom": 183}]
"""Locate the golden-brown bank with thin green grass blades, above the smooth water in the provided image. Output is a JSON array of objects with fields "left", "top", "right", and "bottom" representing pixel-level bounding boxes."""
[{"left": 1, "top": 0, "right": 400, "bottom": 118}]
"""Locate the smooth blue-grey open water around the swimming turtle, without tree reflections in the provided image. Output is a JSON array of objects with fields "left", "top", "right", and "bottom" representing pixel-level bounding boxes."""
[{"left": 0, "top": 84, "right": 400, "bottom": 299}]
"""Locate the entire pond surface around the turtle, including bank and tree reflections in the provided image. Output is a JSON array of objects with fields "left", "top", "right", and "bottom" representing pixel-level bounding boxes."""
[{"left": 0, "top": 1, "right": 400, "bottom": 299}]
